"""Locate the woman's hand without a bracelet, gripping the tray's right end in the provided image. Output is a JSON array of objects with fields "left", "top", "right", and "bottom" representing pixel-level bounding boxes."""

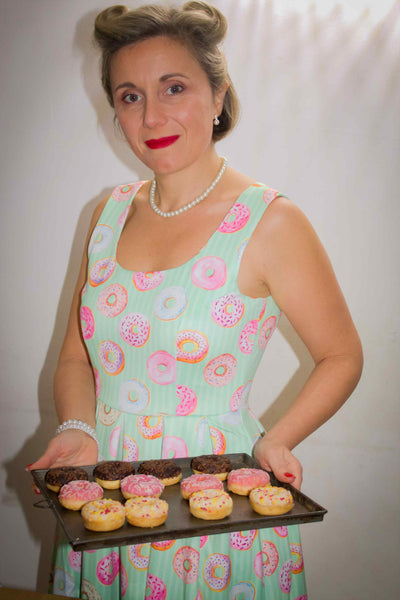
[{"left": 254, "top": 435, "right": 303, "bottom": 490}]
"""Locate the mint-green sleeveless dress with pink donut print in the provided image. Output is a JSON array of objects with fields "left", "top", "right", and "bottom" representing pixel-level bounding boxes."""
[{"left": 53, "top": 182, "right": 307, "bottom": 600}]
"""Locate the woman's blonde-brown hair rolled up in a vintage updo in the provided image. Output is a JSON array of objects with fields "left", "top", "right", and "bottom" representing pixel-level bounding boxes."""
[{"left": 94, "top": 0, "right": 239, "bottom": 141}]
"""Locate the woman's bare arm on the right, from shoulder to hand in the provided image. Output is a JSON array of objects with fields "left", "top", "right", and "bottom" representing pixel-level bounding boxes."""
[{"left": 255, "top": 198, "right": 363, "bottom": 487}]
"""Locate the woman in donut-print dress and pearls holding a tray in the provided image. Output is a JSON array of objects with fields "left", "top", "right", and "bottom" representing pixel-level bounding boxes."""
[{"left": 31, "top": 2, "right": 362, "bottom": 599}]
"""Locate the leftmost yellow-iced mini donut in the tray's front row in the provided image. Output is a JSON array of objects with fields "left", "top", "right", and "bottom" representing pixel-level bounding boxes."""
[{"left": 81, "top": 498, "right": 125, "bottom": 531}]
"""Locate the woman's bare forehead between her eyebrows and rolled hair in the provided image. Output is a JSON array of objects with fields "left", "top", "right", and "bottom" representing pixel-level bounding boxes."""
[{"left": 110, "top": 36, "right": 208, "bottom": 86}]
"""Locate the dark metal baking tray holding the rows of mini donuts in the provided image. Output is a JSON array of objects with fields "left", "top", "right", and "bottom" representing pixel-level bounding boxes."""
[{"left": 32, "top": 454, "right": 327, "bottom": 550}]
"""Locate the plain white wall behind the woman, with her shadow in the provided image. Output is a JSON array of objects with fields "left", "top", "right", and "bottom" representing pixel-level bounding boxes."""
[{"left": 0, "top": 0, "right": 400, "bottom": 600}]
